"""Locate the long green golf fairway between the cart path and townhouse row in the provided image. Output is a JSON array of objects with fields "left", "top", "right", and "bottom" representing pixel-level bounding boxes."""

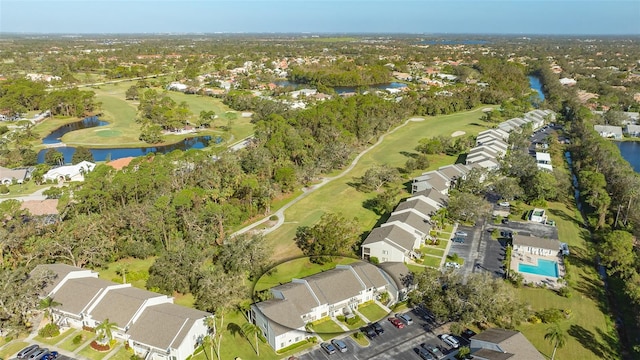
[{"left": 266, "top": 109, "right": 496, "bottom": 259}]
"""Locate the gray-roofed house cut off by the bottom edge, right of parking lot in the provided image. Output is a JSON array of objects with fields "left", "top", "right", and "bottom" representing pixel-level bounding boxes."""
[{"left": 469, "top": 329, "right": 546, "bottom": 360}]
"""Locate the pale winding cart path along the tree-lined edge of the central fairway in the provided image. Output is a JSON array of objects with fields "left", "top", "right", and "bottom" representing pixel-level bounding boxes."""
[{"left": 231, "top": 117, "right": 424, "bottom": 236}]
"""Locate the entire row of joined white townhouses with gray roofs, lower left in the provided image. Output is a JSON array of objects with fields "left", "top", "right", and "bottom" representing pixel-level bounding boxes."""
[{"left": 32, "top": 264, "right": 211, "bottom": 360}]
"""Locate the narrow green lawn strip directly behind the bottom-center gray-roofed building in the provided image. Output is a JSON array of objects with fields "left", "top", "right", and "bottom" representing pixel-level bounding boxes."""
[{"left": 254, "top": 257, "right": 358, "bottom": 291}]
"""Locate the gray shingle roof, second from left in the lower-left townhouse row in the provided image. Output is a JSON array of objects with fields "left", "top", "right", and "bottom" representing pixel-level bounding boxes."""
[{"left": 53, "top": 277, "right": 116, "bottom": 314}]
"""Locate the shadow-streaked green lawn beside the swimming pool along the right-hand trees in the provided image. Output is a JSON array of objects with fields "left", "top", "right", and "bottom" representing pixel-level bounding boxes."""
[{"left": 517, "top": 203, "right": 619, "bottom": 359}]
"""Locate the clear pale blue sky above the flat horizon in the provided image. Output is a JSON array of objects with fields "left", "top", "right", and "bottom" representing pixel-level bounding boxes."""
[{"left": 0, "top": 0, "right": 640, "bottom": 35}]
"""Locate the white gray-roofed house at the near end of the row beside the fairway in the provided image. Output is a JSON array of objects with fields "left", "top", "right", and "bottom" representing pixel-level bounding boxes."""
[{"left": 360, "top": 224, "right": 422, "bottom": 263}]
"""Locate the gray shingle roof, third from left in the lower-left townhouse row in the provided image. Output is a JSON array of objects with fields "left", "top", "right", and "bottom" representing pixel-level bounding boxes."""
[{"left": 90, "top": 287, "right": 169, "bottom": 328}]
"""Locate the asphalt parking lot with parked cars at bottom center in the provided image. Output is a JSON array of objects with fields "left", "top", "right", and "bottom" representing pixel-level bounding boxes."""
[{"left": 299, "top": 310, "right": 468, "bottom": 360}]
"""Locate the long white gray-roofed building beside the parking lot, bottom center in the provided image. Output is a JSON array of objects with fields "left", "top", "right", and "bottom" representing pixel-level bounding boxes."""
[{"left": 249, "top": 262, "right": 409, "bottom": 351}]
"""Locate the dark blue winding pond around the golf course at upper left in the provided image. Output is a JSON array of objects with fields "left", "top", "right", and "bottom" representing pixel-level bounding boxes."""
[{"left": 38, "top": 116, "right": 222, "bottom": 164}]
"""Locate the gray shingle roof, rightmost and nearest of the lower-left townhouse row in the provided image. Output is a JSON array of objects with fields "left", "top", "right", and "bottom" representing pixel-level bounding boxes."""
[{"left": 127, "top": 304, "right": 211, "bottom": 349}]
